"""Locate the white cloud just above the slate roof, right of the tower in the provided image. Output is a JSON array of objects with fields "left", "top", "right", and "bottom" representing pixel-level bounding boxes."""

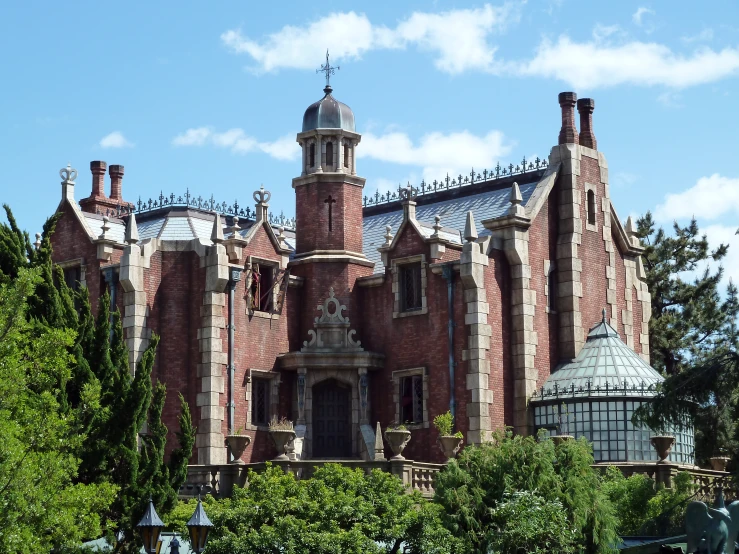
[{"left": 357, "top": 131, "right": 512, "bottom": 179}]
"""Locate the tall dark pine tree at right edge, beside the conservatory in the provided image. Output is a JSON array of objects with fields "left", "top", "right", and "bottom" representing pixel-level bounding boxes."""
[{"left": 636, "top": 212, "right": 739, "bottom": 463}]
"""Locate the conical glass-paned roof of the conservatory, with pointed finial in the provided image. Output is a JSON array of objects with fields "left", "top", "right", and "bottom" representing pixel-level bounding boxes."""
[{"left": 532, "top": 310, "right": 664, "bottom": 401}]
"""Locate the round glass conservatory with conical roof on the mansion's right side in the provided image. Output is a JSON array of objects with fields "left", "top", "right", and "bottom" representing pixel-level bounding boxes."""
[{"left": 531, "top": 310, "right": 694, "bottom": 465}]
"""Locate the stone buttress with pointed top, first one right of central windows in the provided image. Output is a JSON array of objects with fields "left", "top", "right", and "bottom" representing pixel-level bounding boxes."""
[{"left": 462, "top": 212, "right": 493, "bottom": 444}]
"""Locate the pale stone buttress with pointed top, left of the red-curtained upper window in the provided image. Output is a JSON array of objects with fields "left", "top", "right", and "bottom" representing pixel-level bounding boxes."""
[{"left": 195, "top": 214, "right": 228, "bottom": 464}]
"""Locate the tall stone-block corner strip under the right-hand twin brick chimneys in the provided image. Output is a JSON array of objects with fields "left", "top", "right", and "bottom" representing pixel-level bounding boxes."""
[{"left": 549, "top": 144, "right": 585, "bottom": 358}]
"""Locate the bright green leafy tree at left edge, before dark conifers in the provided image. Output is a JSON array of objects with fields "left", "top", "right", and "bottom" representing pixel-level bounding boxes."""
[{"left": 0, "top": 268, "right": 117, "bottom": 553}]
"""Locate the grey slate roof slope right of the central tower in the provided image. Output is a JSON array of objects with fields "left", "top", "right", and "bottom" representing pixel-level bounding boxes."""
[{"left": 363, "top": 181, "right": 537, "bottom": 273}]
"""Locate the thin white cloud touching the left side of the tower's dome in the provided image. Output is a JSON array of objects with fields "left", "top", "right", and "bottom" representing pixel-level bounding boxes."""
[{"left": 172, "top": 127, "right": 300, "bottom": 161}]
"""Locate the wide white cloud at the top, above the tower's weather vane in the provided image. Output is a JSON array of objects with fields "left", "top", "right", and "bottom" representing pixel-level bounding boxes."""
[{"left": 221, "top": 3, "right": 520, "bottom": 74}]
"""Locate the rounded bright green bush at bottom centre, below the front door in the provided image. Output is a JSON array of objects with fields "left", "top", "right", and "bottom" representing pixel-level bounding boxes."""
[{"left": 174, "top": 464, "right": 457, "bottom": 554}]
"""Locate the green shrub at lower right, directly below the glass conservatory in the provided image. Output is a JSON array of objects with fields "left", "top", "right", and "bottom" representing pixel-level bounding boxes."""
[{"left": 603, "top": 466, "right": 694, "bottom": 537}]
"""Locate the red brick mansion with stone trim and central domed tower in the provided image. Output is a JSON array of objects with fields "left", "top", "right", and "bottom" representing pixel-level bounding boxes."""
[{"left": 53, "top": 86, "right": 692, "bottom": 464}]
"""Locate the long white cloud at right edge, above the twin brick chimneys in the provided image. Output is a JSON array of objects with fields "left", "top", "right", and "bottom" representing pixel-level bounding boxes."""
[{"left": 516, "top": 36, "right": 739, "bottom": 89}]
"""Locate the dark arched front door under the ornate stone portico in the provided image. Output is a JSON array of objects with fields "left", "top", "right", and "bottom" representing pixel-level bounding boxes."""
[{"left": 313, "top": 379, "right": 352, "bottom": 458}]
